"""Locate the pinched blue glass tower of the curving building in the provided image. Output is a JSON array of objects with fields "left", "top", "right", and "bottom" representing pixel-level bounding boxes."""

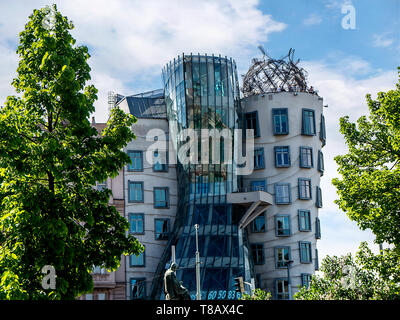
[{"left": 153, "top": 55, "right": 249, "bottom": 300}]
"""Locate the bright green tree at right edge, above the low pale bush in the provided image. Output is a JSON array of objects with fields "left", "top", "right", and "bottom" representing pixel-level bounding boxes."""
[{"left": 332, "top": 68, "right": 400, "bottom": 247}]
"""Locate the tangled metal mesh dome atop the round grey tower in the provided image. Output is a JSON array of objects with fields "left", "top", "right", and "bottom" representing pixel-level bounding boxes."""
[{"left": 242, "top": 46, "right": 308, "bottom": 97}]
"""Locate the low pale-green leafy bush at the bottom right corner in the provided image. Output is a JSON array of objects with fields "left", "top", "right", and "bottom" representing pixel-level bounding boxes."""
[{"left": 294, "top": 242, "right": 400, "bottom": 300}]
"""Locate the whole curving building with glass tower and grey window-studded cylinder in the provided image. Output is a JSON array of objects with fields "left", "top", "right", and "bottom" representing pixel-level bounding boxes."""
[{"left": 106, "top": 47, "right": 326, "bottom": 300}]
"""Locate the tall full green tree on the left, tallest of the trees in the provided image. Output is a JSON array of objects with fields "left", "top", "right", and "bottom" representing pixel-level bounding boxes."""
[{"left": 0, "top": 6, "right": 143, "bottom": 299}]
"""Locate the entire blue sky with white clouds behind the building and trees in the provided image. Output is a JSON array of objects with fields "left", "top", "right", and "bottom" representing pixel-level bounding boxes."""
[{"left": 0, "top": 0, "right": 400, "bottom": 258}]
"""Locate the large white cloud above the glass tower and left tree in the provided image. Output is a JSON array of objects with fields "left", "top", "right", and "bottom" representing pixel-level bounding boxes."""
[{"left": 0, "top": 0, "right": 286, "bottom": 121}]
